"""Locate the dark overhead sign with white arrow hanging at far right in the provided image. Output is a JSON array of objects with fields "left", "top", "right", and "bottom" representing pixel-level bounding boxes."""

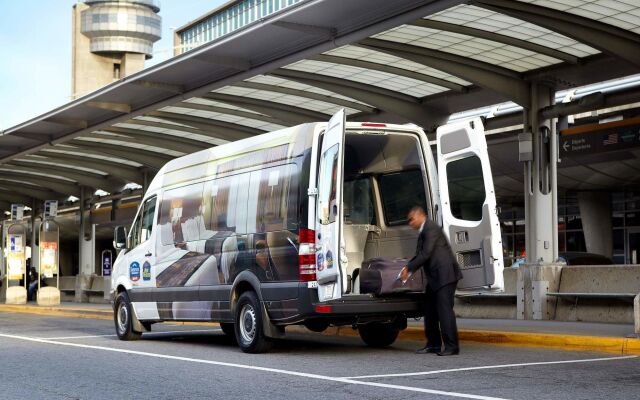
[{"left": 560, "top": 118, "right": 640, "bottom": 156}]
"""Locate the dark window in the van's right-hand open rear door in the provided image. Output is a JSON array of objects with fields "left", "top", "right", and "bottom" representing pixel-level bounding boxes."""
[{"left": 447, "top": 156, "right": 486, "bottom": 221}]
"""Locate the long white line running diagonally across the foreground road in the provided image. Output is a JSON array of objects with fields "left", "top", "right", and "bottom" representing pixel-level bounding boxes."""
[{"left": 0, "top": 334, "right": 507, "bottom": 400}]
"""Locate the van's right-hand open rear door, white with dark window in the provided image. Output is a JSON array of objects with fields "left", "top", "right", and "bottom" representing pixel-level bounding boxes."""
[{"left": 437, "top": 118, "right": 504, "bottom": 290}]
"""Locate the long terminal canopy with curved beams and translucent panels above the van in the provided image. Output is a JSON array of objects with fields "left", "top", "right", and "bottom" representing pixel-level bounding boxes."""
[{"left": 0, "top": 0, "right": 640, "bottom": 210}]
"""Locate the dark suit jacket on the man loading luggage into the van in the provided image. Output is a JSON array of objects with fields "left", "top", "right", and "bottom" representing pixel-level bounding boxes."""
[{"left": 407, "top": 220, "right": 462, "bottom": 291}]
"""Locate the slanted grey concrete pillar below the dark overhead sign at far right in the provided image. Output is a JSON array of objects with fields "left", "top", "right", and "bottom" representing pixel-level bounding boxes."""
[{"left": 578, "top": 192, "right": 613, "bottom": 257}]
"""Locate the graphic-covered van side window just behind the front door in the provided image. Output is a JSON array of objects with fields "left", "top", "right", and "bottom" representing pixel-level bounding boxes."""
[{"left": 158, "top": 183, "right": 204, "bottom": 245}]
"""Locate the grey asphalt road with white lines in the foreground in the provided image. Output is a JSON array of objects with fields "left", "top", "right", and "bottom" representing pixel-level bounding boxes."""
[{"left": 0, "top": 313, "right": 640, "bottom": 400}]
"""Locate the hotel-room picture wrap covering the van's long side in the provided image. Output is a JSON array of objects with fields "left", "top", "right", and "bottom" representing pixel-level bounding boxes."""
[{"left": 131, "top": 138, "right": 299, "bottom": 319}]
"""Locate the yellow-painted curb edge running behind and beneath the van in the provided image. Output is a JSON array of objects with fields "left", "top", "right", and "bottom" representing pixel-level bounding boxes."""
[{"left": 0, "top": 304, "right": 640, "bottom": 356}]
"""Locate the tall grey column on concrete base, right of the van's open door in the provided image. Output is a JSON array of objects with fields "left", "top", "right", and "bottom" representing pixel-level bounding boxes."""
[{"left": 516, "top": 82, "right": 562, "bottom": 320}]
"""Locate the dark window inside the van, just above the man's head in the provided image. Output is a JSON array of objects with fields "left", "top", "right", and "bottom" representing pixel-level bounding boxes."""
[{"left": 378, "top": 170, "right": 428, "bottom": 226}]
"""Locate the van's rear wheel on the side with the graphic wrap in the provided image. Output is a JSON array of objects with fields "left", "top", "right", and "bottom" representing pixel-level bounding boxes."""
[{"left": 234, "top": 292, "right": 273, "bottom": 353}]
